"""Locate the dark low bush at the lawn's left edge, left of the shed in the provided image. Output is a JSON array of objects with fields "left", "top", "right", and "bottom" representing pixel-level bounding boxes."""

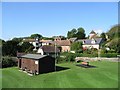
[{"left": 2, "top": 57, "right": 17, "bottom": 68}]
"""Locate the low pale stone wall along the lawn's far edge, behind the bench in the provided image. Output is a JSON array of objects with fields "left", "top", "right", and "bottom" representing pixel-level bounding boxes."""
[{"left": 75, "top": 57, "right": 120, "bottom": 62}]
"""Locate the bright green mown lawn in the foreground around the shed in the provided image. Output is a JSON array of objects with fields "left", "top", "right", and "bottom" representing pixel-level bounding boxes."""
[{"left": 2, "top": 61, "right": 118, "bottom": 88}]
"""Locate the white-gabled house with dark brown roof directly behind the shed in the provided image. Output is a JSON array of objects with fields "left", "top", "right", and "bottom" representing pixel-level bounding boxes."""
[{"left": 37, "top": 45, "right": 60, "bottom": 57}]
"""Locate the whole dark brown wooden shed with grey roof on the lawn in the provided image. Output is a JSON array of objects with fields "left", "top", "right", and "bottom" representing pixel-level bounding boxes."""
[{"left": 18, "top": 54, "right": 55, "bottom": 74}]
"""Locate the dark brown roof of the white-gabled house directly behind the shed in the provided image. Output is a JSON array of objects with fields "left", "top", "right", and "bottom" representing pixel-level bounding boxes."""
[{"left": 40, "top": 45, "right": 60, "bottom": 53}]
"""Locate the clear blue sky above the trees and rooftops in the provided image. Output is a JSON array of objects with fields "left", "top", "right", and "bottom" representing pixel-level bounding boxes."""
[{"left": 1, "top": 2, "right": 118, "bottom": 40}]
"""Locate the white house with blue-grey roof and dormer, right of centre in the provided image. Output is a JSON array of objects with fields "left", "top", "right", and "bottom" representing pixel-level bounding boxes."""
[{"left": 79, "top": 38, "right": 103, "bottom": 49}]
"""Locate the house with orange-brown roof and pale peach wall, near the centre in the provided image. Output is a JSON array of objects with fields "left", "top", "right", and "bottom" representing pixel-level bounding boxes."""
[{"left": 53, "top": 40, "right": 72, "bottom": 52}]
